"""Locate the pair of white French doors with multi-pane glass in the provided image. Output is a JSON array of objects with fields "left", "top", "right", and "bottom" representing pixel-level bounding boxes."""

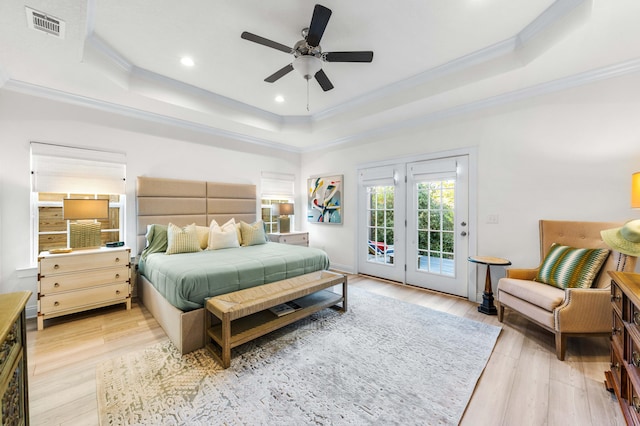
[{"left": 358, "top": 155, "right": 469, "bottom": 297}]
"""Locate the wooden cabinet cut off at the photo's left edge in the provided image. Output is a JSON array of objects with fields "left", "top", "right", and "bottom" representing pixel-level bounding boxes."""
[{"left": 0, "top": 291, "right": 31, "bottom": 426}]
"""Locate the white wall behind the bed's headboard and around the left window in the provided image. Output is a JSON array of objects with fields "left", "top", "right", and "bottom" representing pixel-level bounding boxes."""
[{"left": 0, "top": 90, "right": 300, "bottom": 314}]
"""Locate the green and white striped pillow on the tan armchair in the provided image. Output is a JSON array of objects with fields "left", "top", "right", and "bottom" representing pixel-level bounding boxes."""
[{"left": 535, "top": 243, "right": 609, "bottom": 288}]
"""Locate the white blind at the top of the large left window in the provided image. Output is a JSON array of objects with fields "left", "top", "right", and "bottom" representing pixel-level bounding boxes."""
[{"left": 31, "top": 142, "right": 126, "bottom": 194}]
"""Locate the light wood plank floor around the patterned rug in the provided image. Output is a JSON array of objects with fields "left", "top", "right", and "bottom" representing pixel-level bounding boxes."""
[{"left": 27, "top": 276, "right": 624, "bottom": 426}]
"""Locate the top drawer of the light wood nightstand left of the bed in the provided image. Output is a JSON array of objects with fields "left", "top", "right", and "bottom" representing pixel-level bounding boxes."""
[{"left": 38, "top": 250, "right": 129, "bottom": 277}]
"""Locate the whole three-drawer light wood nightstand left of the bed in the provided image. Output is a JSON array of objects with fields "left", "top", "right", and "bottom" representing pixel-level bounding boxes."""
[{"left": 38, "top": 247, "right": 131, "bottom": 330}]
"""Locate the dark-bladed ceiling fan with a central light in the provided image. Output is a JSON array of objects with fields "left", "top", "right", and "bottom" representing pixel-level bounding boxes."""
[{"left": 241, "top": 4, "right": 373, "bottom": 92}]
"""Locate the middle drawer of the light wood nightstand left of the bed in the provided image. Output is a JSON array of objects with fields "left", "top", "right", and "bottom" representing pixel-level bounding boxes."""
[{"left": 40, "top": 265, "right": 129, "bottom": 295}]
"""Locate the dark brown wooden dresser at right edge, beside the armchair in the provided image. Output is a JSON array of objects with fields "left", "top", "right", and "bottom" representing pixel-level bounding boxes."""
[{"left": 605, "top": 271, "right": 640, "bottom": 425}]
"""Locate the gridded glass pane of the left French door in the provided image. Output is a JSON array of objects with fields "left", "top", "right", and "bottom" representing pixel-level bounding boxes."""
[{"left": 366, "top": 186, "right": 395, "bottom": 264}]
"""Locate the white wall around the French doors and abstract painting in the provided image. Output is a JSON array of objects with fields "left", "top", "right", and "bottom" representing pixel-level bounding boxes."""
[{"left": 301, "top": 70, "right": 640, "bottom": 297}]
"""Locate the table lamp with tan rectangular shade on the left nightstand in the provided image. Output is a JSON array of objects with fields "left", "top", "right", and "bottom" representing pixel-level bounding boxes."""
[{"left": 62, "top": 198, "right": 109, "bottom": 249}]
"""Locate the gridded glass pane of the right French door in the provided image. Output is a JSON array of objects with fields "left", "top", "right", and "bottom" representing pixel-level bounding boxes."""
[{"left": 416, "top": 179, "right": 455, "bottom": 276}]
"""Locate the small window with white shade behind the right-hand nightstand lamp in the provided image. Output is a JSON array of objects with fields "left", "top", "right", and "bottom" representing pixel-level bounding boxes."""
[{"left": 260, "top": 172, "right": 295, "bottom": 233}]
